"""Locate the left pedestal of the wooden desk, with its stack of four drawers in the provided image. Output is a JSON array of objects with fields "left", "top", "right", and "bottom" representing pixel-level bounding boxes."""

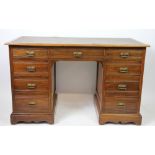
[{"left": 9, "top": 46, "right": 55, "bottom": 124}]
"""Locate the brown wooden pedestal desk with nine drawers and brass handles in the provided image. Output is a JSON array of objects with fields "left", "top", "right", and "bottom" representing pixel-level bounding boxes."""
[{"left": 7, "top": 37, "right": 149, "bottom": 125}]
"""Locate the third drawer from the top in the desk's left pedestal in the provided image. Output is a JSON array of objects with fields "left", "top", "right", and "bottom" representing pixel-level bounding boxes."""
[{"left": 14, "top": 79, "right": 49, "bottom": 92}]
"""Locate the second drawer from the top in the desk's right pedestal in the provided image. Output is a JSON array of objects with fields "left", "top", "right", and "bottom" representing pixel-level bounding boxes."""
[{"left": 106, "top": 63, "right": 141, "bottom": 75}]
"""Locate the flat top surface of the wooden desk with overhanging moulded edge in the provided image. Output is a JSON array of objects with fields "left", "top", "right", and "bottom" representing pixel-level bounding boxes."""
[{"left": 6, "top": 36, "right": 149, "bottom": 47}]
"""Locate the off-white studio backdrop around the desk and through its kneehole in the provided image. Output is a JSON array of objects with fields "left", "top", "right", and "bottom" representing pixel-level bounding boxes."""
[{"left": 0, "top": 29, "right": 155, "bottom": 125}]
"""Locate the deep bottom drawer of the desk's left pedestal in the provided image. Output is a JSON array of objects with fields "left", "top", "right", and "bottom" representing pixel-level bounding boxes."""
[{"left": 13, "top": 96, "right": 51, "bottom": 113}]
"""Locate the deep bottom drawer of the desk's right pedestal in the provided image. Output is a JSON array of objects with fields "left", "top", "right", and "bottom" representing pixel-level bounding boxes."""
[{"left": 103, "top": 97, "right": 139, "bottom": 114}]
